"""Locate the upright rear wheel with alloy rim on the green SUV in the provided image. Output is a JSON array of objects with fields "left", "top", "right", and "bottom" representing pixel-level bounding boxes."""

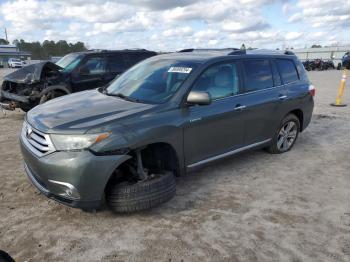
[{"left": 266, "top": 114, "right": 300, "bottom": 154}]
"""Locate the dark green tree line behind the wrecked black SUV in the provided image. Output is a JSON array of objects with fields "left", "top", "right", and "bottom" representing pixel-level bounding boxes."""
[{"left": 0, "top": 39, "right": 87, "bottom": 60}]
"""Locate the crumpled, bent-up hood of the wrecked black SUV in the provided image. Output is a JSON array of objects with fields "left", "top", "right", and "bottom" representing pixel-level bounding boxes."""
[{"left": 4, "top": 61, "right": 62, "bottom": 84}]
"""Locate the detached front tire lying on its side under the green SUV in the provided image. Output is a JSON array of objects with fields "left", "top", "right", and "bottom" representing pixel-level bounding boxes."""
[{"left": 106, "top": 172, "right": 176, "bottom": 213}]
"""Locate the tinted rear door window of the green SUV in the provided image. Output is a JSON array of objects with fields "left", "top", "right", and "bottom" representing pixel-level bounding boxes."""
[{"left": 243, "top": 60, "right": 273, "bottom": 92}]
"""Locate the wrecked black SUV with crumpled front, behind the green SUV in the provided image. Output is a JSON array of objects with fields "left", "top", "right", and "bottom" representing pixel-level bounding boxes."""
[{"left": 0, "top": 49, "right": 157, "bottom": 112}]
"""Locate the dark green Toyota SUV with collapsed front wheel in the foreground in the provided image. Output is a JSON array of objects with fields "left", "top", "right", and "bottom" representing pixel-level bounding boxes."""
[{"left": 20, "top": 49, "right": 315, "bottom": 212}]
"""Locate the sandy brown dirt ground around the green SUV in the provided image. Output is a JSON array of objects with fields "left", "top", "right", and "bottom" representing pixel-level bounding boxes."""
[{"left": 0, "top": 70, "right": 350, "bottom": 262}]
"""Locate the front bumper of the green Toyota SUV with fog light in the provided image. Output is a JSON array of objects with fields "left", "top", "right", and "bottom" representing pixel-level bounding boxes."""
[{"left": 20, "top": 136, "right": 129, "bottom": 208}]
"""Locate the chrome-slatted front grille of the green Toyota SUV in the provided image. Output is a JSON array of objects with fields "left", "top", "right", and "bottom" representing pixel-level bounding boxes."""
[{"left": 21, "top": 122, "right": 55, "bottom": 157}]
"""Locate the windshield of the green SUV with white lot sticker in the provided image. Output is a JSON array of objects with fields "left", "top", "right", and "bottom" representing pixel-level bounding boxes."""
[{"left": 107, "top": 59, "right": 198, "bottom": 104}]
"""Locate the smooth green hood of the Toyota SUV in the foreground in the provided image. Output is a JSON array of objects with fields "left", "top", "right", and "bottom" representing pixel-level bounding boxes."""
[{"left": 27, "top": 90, "right": 155, "bottom": 133}]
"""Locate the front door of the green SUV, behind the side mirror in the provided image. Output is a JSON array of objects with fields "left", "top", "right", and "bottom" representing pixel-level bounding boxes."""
[{"left": 184, "top": 62, "right": 244, "bottom": 168}]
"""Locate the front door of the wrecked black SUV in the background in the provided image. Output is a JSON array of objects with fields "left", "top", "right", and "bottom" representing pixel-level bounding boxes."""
[{"left": 72, "top": 54, "right": 107, "bottom": 92}]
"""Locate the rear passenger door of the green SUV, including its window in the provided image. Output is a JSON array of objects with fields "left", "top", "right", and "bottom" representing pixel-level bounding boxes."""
[{"left": 237, "top": 58, "right": 280, "bottom": 146}]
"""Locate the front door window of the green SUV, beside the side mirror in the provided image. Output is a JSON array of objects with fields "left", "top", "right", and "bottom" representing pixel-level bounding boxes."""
[{"left": 192, "top": 63, "right": 239, "bottom": 99}]
